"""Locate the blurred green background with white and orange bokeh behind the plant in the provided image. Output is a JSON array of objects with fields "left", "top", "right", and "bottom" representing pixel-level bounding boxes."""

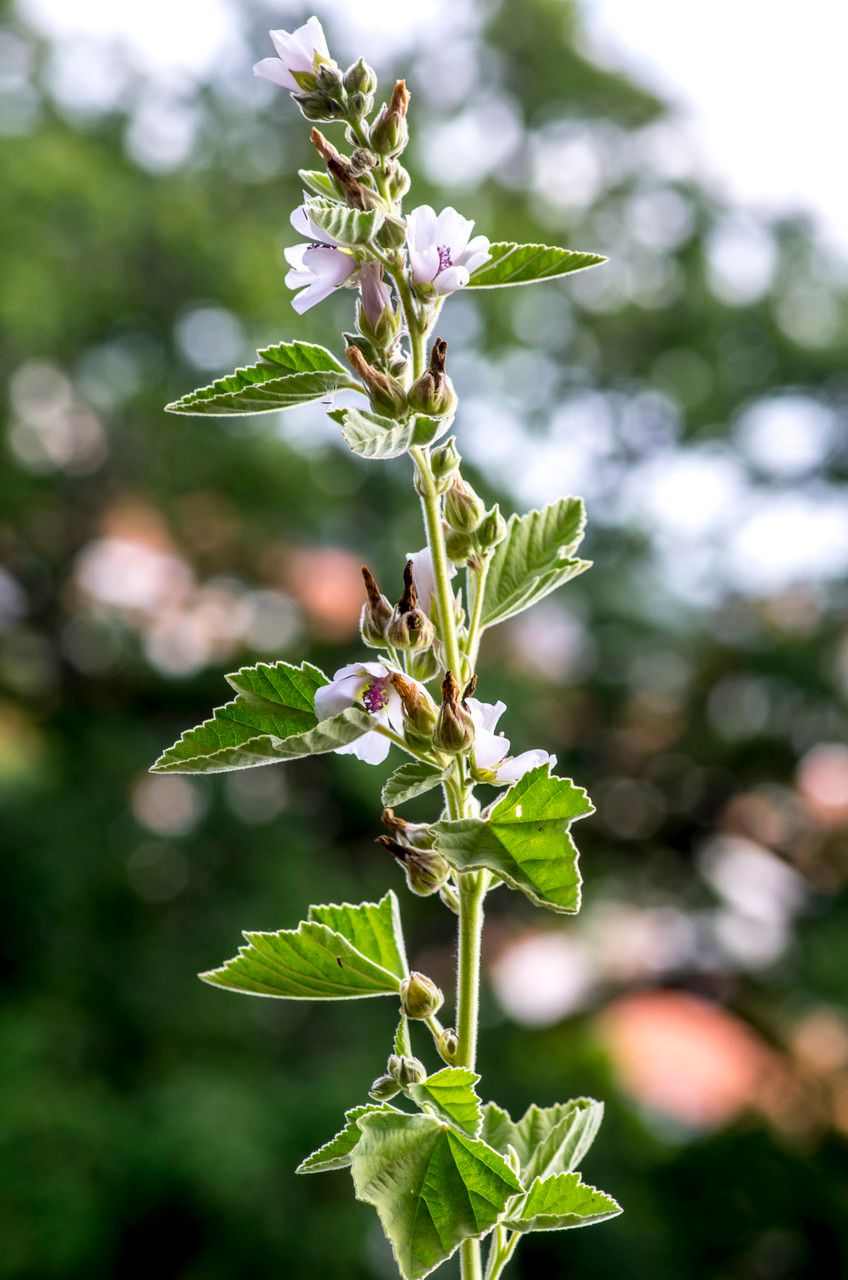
[{"left": 0, "top": 0, "right": 848, "bottom": 1280}]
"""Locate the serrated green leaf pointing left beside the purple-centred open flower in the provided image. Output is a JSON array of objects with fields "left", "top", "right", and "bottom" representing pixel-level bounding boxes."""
[{"left": 151, "top": 662, "right": 374, "bottom": 773}]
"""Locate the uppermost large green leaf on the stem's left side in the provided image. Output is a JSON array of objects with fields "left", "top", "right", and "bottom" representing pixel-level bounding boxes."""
[{"left": 165, "top": 342, "right": 351, "bottom": 417}]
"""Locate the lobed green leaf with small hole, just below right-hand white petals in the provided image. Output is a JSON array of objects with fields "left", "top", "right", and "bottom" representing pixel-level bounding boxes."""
[{"left": 433, "top": 764, "right": 594, "bottom": 914}]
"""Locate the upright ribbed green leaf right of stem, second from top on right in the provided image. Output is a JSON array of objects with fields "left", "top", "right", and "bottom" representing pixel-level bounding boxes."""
[{"left": 482, "top": 498, "right": 591, "bottom": 627}]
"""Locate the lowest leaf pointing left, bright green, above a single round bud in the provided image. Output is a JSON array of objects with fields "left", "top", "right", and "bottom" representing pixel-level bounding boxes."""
[{"left": 200, "top": 890, "right": 406, "bottom": 1000}]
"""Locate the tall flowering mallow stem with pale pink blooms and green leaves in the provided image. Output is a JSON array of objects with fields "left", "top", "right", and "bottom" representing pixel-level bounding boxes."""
[{"left": 154, "top": 18, "right": 619, "bottom": 1280}]
